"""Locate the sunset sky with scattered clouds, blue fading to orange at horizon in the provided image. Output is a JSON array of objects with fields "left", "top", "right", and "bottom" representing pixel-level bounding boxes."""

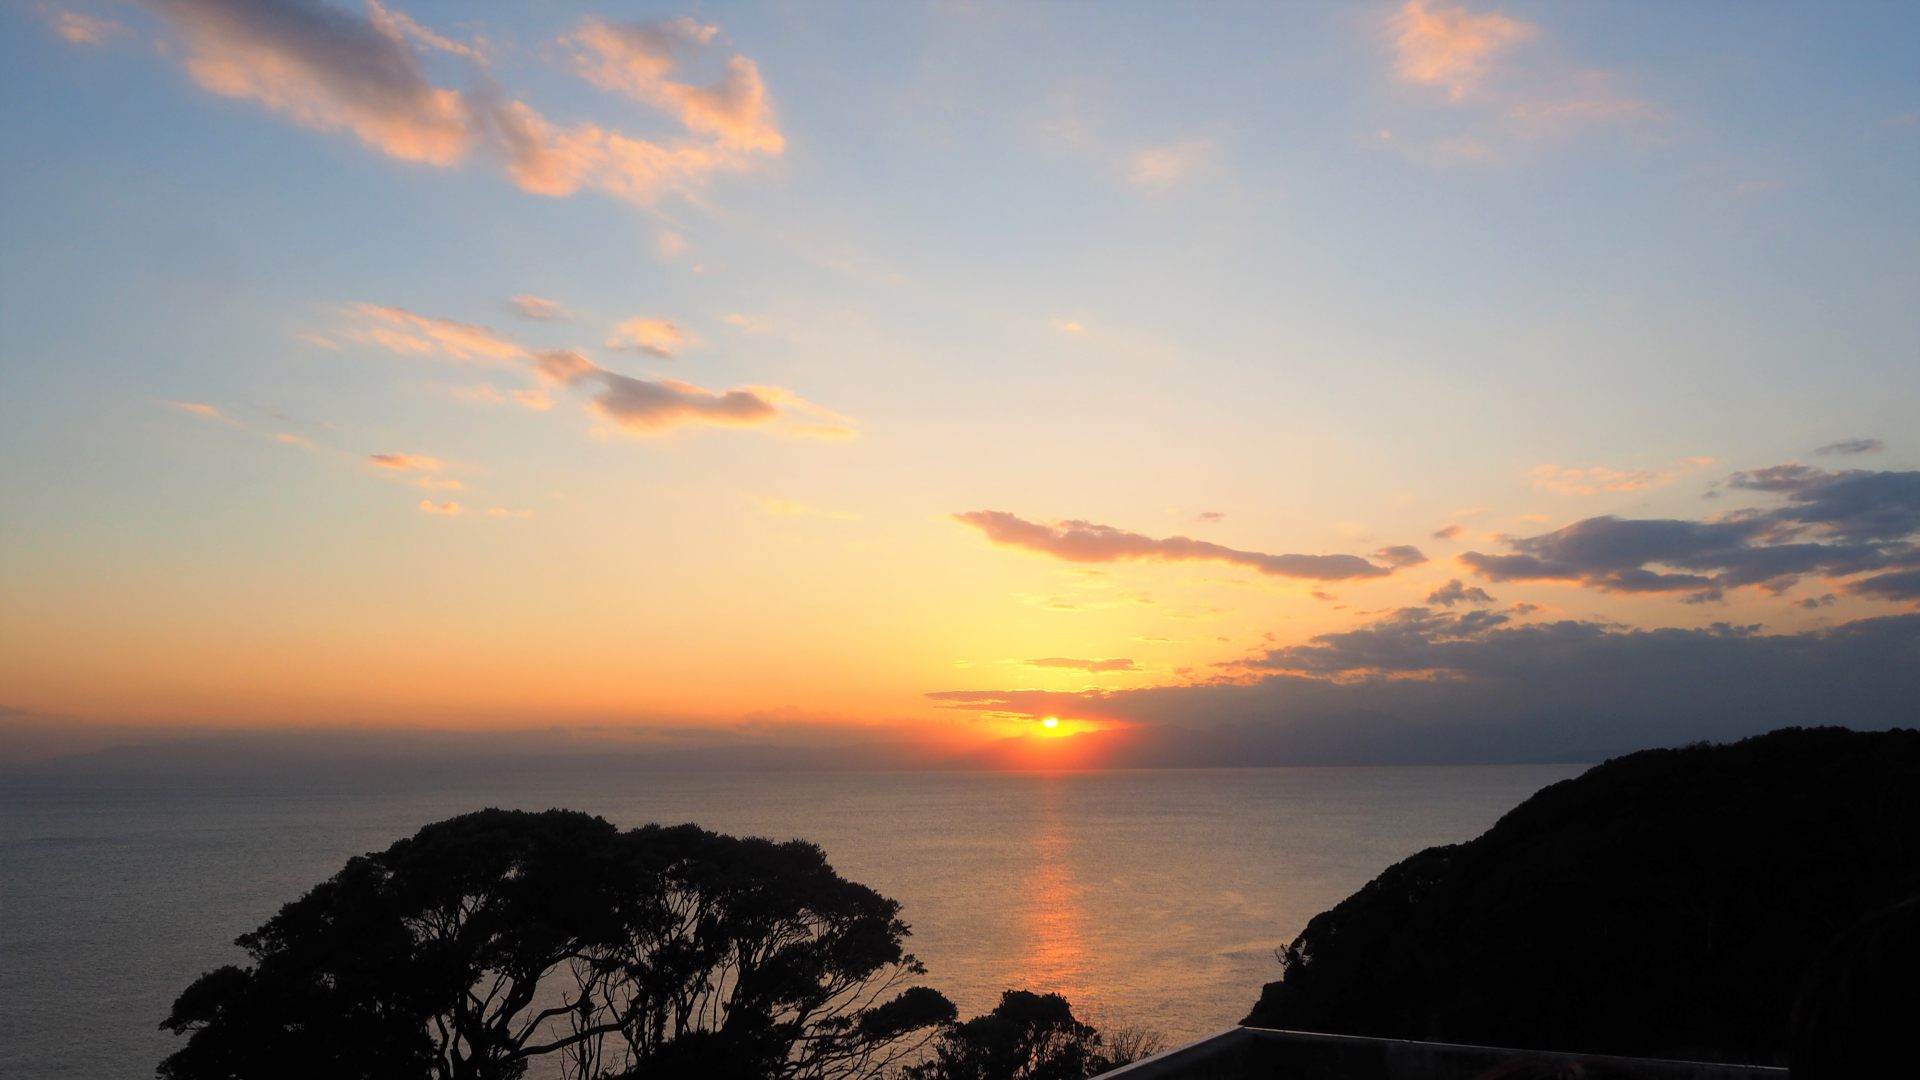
[{"left": 0, "top": 0, "right": 1920, "bottom": 767}]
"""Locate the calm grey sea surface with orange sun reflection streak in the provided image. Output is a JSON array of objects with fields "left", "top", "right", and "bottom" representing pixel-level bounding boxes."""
[{"left": 0, "top": 763, "right": 1582, "bottom": 1080}]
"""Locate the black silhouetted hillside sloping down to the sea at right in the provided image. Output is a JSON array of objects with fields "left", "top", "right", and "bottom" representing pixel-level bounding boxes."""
[{"left": 1246, "top": 728, "right": 1920, "bottom": 1063}]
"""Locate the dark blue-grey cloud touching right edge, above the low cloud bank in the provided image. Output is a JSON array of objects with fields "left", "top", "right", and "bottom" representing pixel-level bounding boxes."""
[{"left": 1459, "top": 465, "right": 1920, "bottom": 600}]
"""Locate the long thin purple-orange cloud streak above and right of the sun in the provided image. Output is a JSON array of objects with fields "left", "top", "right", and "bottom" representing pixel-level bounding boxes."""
[{"left": 952, "top": 509, "right": 1411, "bottom": 580}]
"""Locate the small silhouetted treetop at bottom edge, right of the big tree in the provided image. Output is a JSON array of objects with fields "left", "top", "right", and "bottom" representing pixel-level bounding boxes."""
[{"left": 904, "top": 990, "right": 1136, "bottom": 1080}]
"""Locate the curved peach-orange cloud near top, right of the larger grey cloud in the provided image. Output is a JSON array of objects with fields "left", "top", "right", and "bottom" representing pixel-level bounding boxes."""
[{"left": 563, "top": 17, "right": 787, "bottom": 154}]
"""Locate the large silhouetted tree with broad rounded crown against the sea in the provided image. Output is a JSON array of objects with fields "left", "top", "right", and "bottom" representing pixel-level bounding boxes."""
[{"left": 159, "top": 809, "right": 954, "bottom": 1080}]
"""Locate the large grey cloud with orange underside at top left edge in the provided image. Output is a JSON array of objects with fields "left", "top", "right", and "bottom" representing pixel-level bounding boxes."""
[{"left": 137, "top": 0, "right": 474, "bottom": 165}]
